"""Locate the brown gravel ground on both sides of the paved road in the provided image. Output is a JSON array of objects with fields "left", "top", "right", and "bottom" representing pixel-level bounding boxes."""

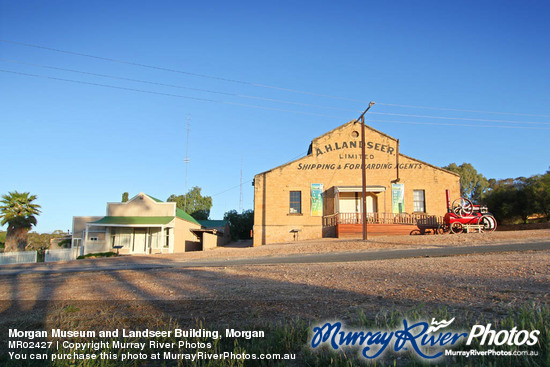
[{"left": 0, "top": 230, "right": 550, "bottom": 322}]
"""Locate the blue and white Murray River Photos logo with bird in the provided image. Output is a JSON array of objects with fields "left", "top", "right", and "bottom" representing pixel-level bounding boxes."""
[{"left": 310, "top": 318, "right": 540, "bottom": 361}]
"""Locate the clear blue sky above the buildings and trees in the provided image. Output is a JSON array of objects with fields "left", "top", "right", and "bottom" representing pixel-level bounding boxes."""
[{"left": 0, "top": 0, "right": 550, "bottom": 232}]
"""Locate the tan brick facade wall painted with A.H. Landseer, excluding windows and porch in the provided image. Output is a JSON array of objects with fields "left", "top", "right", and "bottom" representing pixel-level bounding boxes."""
[{"left": 254, "top": 122, "right": 460, "bottom": 246}]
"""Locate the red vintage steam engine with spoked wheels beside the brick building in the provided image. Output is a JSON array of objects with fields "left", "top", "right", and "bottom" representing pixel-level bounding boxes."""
[{"left": 444, "top": 190, "right": 497, "bottom": 233}]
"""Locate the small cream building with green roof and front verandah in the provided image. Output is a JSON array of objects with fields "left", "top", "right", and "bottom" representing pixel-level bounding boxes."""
[{"left": 73, "top": 192, "right": 202, "bottom": 254}]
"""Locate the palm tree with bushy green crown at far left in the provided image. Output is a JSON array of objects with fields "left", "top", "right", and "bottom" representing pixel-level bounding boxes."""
[{"left": 0, "top": 191, "right": 40, "bottom": 252}]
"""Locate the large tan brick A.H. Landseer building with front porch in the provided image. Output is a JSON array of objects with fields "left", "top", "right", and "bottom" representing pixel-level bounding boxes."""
[{"left": 254, "top": 121, "right": 460, "bottom": 246}]
